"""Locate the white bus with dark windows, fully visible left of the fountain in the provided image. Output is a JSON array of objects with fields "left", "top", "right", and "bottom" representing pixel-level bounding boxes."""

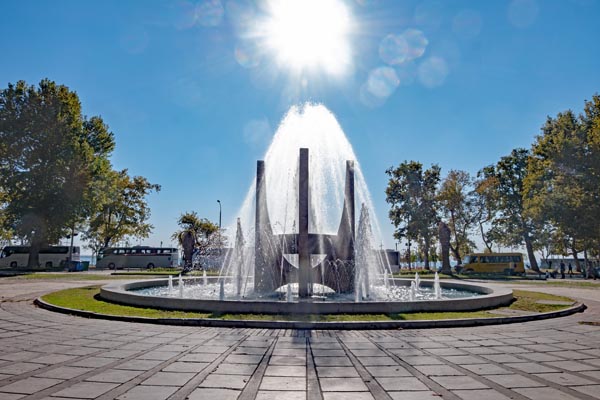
[{"left": 96, "top": 246, "right": 179, "bottom": 269}]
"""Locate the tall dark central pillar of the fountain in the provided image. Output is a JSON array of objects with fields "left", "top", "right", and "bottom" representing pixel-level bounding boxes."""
[{"left": 298, "top": 149, "right": 312, "bottom": 298}]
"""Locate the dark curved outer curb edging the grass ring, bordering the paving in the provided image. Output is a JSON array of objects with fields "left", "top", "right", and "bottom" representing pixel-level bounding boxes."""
[{"left": 34, "top": 297, "right": 587, "bottom": 330}]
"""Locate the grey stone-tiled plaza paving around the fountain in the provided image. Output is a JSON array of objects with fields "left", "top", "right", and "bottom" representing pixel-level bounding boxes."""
[{"left": 0, "top": 279, "right": 600, "bottom": 400}]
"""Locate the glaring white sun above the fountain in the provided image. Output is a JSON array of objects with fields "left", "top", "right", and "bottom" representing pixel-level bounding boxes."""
[{"left": 263, "top": 0, "right": 351, "bottom": 75}]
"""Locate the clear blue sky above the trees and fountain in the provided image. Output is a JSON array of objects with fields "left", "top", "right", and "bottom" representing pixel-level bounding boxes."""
[{"left": 0, "top": 0, "right": 600, "bottom": 252}]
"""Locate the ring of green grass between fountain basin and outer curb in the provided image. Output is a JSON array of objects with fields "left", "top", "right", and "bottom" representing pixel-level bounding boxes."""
[{"left": 42, "top": 286, "right": 573, "bottom": 322}]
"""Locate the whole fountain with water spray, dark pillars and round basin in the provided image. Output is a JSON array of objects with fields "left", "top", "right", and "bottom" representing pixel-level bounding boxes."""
[{"left": 101, "top": 105, "right": 512, "bottom": 314}]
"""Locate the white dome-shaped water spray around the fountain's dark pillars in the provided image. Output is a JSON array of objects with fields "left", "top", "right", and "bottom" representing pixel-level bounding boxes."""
[{"left": 220, "top": 103, "right": 389, "bottom": 298}]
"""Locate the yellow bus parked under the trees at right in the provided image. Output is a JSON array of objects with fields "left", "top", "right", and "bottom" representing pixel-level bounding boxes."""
[{"left": 461, "top": 253, "right": 525, "bottom": 275}]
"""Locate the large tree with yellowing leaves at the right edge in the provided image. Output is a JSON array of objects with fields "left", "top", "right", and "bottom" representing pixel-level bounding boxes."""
[{"left": 525, "top": 95, "right": 600, "bottom": 269}]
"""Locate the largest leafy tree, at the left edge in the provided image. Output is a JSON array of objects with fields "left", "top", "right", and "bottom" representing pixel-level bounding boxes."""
[{"left": 0, "top": 79, "right": 114, "bottom": 268}]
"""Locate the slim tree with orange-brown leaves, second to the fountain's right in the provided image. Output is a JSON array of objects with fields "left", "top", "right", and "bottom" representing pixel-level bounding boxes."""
[{"left": 438, "top": 170, "right": 477, "bottom": 264}]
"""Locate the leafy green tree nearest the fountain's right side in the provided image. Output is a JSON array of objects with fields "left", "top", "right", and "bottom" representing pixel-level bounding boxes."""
[{"left": 386, "top": 161, "right": 440, "bottom": 269}]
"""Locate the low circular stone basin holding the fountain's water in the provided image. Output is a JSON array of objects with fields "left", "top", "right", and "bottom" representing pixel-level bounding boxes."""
[{"left": 100, "top": 278, "right": 513, "bottom": 314}]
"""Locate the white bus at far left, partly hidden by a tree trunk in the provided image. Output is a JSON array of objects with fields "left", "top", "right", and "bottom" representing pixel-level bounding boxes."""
[{"left": 0, "top": 246, "right": 80, "bottom": 268}]
